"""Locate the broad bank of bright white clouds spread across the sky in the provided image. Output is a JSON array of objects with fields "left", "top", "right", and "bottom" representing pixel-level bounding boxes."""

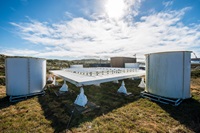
[{"left": 4, "top": 0, "right": 200, "bottom": 59}]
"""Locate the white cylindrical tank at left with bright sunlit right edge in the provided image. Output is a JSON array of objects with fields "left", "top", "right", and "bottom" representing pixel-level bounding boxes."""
[{"left": 5, "top": 58, "right": 46, "bottom": 96}]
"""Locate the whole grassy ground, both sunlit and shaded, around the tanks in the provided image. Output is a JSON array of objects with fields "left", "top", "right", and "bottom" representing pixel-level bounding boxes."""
[{"left": 0, "top": 77, "right": 200, "bottom": 133}]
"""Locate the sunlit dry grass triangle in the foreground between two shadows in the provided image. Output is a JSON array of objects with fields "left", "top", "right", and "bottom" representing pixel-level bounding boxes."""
[{"left": 72, "top": 99, "right": 197, "bottom": 133}]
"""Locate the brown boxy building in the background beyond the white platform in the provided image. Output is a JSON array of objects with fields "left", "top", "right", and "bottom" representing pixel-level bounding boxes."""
[{"left": 110, "top": 57, "right": 137, "bottom": 68}]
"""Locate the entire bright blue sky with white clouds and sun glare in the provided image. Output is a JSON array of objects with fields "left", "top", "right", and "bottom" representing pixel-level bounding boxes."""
[{"left": 0, "top": 0, "right": 200, "bottom": 60}]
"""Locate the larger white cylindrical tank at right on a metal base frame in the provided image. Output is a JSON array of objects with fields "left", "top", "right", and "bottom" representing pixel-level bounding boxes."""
[{"left": 145, "top": 51, "right": 191, "bottom": 99}]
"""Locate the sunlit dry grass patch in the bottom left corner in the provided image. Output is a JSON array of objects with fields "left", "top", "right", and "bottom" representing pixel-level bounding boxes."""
[{"left": 0, "top": 87, "right": 53, "bottom": 133}]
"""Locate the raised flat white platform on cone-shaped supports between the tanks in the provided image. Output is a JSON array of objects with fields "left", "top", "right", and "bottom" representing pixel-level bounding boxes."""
[{"left": 50, "top": 67, "right": 145, "bottom": 87}]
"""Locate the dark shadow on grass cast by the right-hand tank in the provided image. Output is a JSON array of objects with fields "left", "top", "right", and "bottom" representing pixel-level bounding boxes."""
[{"left": 158, "top": 98, "right": 200, "bottom": 133}]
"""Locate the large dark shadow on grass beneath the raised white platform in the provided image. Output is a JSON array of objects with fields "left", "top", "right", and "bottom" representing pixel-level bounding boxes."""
[{"left": 39, "top": 80, "right": 141, "bottom": 132}]
